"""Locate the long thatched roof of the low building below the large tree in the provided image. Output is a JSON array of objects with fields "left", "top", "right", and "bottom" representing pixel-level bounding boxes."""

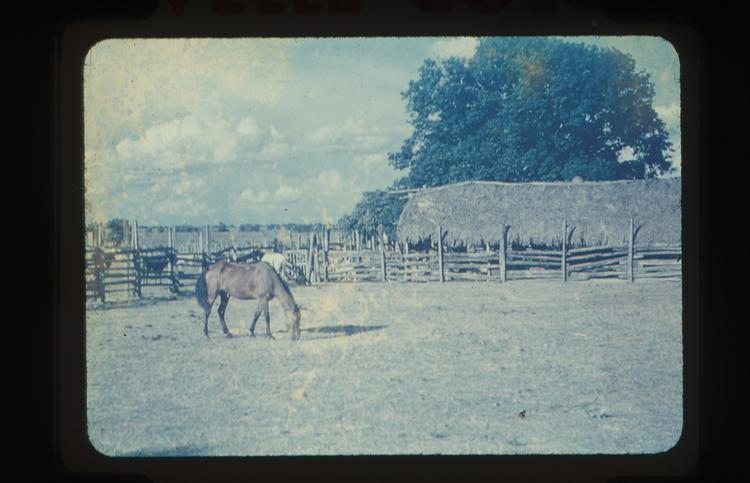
[{"left": 397, "top": 178, "right": 682, "bottom": 245}]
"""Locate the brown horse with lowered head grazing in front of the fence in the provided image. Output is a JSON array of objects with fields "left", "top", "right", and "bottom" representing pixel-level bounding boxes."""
[{"left": 195, "top": 260, "right": 301, "bottom": 340}]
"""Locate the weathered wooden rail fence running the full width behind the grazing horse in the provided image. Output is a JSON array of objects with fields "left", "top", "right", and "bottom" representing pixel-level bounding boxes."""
[{"left": 86, "top": 221, "right": 682, "bottom": 301}]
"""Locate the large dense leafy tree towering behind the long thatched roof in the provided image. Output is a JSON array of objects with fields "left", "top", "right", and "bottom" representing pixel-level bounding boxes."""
[{"left": 389, "top": 37, "right": 671, "bottom": 188}]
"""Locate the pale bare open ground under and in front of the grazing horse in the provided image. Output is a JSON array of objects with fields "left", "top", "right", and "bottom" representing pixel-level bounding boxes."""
[{"left": 86, "top": 280, "right": 682, "bottom": 456}]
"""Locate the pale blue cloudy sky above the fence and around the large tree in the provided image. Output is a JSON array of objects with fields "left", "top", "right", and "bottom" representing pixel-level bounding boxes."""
[{"left": 84, "top": 37, "right": 680, "bottom": 224}]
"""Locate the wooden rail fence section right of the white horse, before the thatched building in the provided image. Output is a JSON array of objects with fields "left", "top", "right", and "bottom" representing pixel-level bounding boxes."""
[{"left": 305, "top": 220, "right": 682, "bottom": 282}]
